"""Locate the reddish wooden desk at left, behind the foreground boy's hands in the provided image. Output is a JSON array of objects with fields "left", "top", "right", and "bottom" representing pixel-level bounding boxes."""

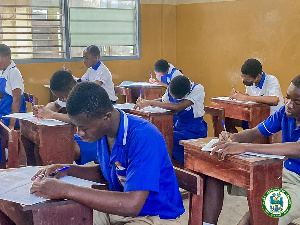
[{"left": 20, "top": 120, "right": 75, "bottom": 165}]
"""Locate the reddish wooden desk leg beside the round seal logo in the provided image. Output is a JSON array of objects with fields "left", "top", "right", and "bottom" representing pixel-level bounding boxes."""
[{"left": 247, "top": 162, "right": 282, "bottom": 225}]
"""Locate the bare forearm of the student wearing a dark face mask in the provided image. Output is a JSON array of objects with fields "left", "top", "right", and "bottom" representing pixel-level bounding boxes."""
[{"left": 230, "top": 91, "right": 279, "bottom": 105}]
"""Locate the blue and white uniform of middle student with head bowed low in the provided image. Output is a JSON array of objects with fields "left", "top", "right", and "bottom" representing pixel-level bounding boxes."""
[{"left": 162, "top": 82, "right": 207, "bottom": 163}]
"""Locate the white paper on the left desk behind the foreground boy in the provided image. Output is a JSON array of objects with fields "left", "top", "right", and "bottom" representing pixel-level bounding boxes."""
[{"left": 3, "top": 112, "right": 68, "bottom": 126}]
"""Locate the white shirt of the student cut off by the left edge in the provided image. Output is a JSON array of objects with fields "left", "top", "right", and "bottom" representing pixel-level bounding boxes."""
[{"left": 0, "top": 60, "right": 24, "bottom": 96}]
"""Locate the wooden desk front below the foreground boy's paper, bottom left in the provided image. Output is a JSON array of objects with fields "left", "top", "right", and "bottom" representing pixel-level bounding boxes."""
[{"left": 0, "top": 200, "right": 93, "bottom": 225}]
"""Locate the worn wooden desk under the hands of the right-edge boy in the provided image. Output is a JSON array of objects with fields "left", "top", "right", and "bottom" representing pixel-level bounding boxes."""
[{"left": 180, "top": 138, "right": 282, "bottom": 225}]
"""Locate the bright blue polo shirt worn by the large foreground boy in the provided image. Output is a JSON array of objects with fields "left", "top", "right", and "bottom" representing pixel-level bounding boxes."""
[{"left": 98, "top": 110, "right": 184, "bottom": 219}]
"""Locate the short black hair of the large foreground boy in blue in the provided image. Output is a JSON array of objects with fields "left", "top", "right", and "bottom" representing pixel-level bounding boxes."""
[{"left": 67, "top": 82, "right": 114, "bottom": 118}]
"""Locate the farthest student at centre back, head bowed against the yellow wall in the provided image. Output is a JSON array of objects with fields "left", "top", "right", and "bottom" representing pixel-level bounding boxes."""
[{"left": 149, "top": 59, "right": 183, "bottom": 87}]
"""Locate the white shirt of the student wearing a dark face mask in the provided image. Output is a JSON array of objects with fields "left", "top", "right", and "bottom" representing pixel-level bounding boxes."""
[{"left": 246, "top": 75, "right": 284, "bottom": 115}]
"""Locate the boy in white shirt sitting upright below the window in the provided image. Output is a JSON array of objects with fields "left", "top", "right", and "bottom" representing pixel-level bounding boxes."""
[{"left": 63, "top": 45, "right": 118, "bottom": 103}]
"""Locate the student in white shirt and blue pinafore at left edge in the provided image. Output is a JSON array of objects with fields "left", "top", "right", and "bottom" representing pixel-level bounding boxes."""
[{"left": 0, "top": 44, "right": 26, "bottom": 164}]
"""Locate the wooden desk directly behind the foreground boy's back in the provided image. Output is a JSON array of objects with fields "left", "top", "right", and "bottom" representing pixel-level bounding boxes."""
[{"left": 124, "top": 110, "right": 173, "bottom": 159}]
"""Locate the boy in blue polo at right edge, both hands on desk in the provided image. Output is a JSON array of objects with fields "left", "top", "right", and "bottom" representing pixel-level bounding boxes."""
[{"left": 204, "top": 75, "right": 300, "bottom": 225}]
